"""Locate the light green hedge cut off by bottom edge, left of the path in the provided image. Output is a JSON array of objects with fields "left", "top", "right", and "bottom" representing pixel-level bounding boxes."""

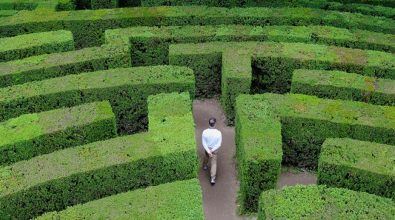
[{"left": 37, "top": 179, "right": 204, "bottom": 220}]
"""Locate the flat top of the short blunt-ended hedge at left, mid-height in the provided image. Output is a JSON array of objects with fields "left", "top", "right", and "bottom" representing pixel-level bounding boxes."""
[{"left": 0, "top": 101, "right": 115, "bottom": 148}]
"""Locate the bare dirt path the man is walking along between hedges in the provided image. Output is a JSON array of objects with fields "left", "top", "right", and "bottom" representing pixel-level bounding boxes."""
[{"left": 193, "top": 99, "right": 248, "bottom": 220}]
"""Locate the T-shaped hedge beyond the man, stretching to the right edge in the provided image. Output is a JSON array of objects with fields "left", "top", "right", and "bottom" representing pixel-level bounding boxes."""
[{"left": 169, "top": 42, "right": 395, "bottom": 119}]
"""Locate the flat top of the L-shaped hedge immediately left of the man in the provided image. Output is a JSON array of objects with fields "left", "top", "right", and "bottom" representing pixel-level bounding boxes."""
[{"left": 0, "top": 93, "right": 196, "bottom": 196}]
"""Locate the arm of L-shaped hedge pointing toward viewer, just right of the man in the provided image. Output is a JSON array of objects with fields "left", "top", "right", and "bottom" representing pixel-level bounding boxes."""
[{"left": 236, "top": 96, "right": 283, "bottom": 212}]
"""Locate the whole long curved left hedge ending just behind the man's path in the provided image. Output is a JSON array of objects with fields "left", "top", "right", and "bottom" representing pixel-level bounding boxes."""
[{"left": 0, "top": 66, "right": 195, "bottom": 133}]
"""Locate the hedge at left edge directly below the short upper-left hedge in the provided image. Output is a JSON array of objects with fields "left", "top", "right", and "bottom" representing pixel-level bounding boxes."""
[{"left": 0, "top": 45, "right": 130, "bottom": 87}]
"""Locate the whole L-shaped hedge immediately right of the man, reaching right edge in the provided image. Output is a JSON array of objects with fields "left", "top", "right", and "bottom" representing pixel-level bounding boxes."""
[{"left": 236, "top": 93, "right": 395, "bottom": 212}]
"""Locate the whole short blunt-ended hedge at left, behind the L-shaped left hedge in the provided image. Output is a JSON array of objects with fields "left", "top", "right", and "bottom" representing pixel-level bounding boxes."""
[{"left": 0, "top": 101, "right": 117, "bottom": 165}]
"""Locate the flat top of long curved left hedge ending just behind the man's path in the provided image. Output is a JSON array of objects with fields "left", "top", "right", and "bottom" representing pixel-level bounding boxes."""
[{"left": 0, "top": 66, "right": 194, "bottom": 103}]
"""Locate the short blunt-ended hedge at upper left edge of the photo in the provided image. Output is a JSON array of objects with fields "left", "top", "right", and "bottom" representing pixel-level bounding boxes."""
[{"left": 0, "top": 30, "right": 74, "bottom": 62}]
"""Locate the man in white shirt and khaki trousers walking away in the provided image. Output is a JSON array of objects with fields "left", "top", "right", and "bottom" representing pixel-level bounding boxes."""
[{"left": 202, "top": 118, "right": 222, "bottom": 185}]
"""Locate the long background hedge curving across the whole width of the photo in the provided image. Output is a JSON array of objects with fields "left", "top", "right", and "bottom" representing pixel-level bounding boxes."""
[{"left": 0, "top": 6, "right": 395, "bottom": 48}]
